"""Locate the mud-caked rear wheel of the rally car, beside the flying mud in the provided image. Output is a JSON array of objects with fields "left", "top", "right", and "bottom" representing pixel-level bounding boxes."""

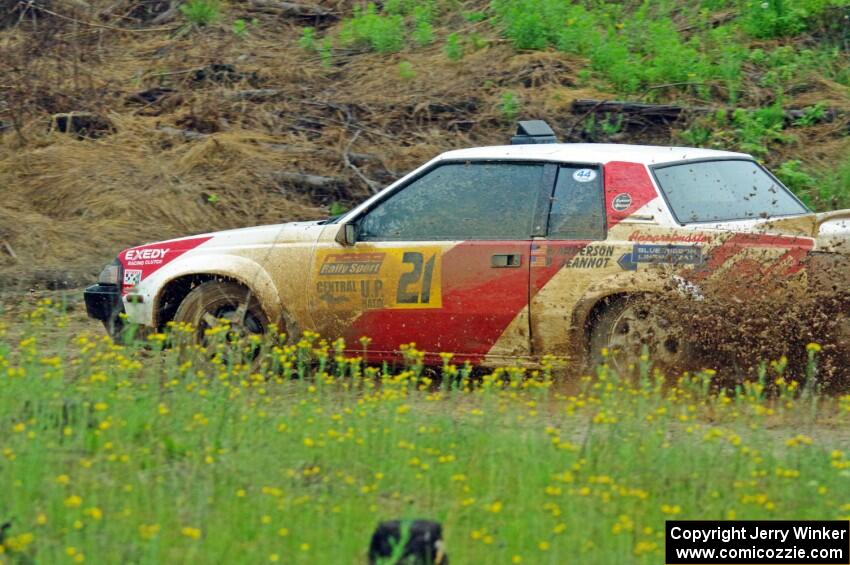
[{"left": 588, "top": 295, "right": 696, "bottom": 377}]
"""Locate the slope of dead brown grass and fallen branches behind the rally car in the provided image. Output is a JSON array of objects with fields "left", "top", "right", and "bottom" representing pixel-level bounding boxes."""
[{"left": 0, "top": 0, "right": 850, "bottom": 289}]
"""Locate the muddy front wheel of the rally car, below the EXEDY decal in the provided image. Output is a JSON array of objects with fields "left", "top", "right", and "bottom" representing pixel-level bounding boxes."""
[{"left": 174, "top": 281, "right": 269, "bottom": 343}]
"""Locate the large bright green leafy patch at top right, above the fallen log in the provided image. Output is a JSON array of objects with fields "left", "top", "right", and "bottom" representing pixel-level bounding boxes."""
[{"left": 491, "top": 0, "right": 850, "bottom": 104}]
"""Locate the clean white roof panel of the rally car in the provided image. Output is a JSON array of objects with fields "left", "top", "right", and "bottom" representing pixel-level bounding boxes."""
[{"left": 438, "top": 143, "right": 752, "bottom": 165}]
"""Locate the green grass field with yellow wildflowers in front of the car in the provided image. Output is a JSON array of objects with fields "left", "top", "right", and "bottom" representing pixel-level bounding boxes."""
[{"left": 0, "top": 300, "right": 850, "bottom": 564}]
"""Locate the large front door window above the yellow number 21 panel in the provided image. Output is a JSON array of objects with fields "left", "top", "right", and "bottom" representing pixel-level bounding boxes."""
[{"left": 358, "top": 162, "right": 544, "bottom": 241}]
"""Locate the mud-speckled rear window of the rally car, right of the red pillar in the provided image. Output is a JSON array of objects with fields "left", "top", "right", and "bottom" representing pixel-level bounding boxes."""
[{"left": 653, "top": 159, "right": 809, "bottom": 224}]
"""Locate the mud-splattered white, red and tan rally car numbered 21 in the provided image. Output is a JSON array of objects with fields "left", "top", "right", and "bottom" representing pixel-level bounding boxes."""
[{"left": 85, "top": 121, "right": 850, "bottom": 366}]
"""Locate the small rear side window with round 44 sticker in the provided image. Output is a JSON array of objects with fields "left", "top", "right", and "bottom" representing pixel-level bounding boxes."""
[{"left": 548, "top": 166, "right": 605, "bottom": 240}]
